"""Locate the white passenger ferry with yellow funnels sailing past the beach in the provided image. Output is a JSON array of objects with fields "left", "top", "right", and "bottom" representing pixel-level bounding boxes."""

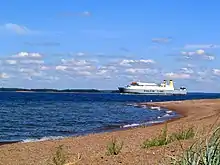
[{"left": 118, "top": 80, "right": 187, "bottom": 95}]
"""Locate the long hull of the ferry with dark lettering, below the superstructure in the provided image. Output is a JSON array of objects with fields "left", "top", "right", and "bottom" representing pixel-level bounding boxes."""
[{"left": 118, "top": 87, "right": 187, "bottom": 95}]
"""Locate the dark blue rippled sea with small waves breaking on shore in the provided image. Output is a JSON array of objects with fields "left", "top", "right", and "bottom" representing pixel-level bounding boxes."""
[{"left": 0, "top": 92, "right": 220, "bottom": 143}]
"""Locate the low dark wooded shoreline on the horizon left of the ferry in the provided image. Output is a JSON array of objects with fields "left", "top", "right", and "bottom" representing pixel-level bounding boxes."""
[{"left": 0, "top": 87, "right": 119, "bottom": 93}]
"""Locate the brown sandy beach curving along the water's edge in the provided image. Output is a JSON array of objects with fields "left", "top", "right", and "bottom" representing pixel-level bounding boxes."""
[{"left": 0, "top": 99, "right": 220, "bottom": 165}]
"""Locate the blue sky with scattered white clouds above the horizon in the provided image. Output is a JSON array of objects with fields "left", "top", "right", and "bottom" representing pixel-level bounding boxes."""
[{"left": 0, "top": 0, "right": 220, "bottom": 92}]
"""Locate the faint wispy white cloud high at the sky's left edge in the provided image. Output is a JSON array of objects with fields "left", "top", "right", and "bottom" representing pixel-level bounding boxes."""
[{"left": 0, "top": 23, "right": 39, "bottom": 35}]
